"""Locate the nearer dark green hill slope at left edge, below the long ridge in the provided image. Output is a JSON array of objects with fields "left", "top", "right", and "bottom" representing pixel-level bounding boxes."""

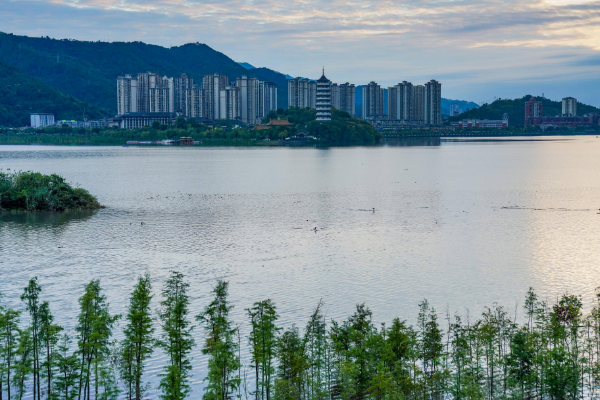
[{"left": 0, "top": 61, "right": 111, "bottom": 126}]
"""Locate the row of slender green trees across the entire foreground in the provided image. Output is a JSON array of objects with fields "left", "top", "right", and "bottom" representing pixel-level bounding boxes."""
[{"left": 0, "top": 271, "right": 600, "bottom": 400}]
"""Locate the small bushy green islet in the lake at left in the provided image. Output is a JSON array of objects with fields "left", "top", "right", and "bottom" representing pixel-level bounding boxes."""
[{"left": 0, "top": 170, "right": 103, "bottom": 212}]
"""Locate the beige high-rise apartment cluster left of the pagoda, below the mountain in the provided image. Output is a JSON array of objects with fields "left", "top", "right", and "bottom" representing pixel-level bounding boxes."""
[{"left": 117, "top": 72, "right": 277, "bottom": 126}]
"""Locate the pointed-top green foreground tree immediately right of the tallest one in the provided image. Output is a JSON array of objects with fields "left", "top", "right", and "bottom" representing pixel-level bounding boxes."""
[{"left": 196, "top": 280, "right": 240, "bottom": 400}]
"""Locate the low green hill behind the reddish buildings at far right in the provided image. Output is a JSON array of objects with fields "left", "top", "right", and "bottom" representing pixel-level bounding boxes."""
[{"left": 450, "top": 95, "right": 600, "bottom": 126}]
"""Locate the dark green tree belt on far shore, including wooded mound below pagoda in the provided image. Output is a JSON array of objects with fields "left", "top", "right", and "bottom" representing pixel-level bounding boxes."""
[{"left": 0, "top": 108, "right": 381, "bottom": 146}]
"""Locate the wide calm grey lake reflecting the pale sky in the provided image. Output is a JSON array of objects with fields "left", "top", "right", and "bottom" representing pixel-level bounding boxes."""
[{"left": 0, "top": 136, "right": 600, "bottom": 395}]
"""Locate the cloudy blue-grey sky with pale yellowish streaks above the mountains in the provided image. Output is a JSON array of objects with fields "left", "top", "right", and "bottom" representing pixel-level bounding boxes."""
[{"left": 0, "top": 0, "right": 600, "bottom": 106}]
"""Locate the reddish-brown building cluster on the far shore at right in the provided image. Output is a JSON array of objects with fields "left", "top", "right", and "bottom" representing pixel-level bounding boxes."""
[{"left": 525, "top": 97, "right": 600, "bottom": 128}]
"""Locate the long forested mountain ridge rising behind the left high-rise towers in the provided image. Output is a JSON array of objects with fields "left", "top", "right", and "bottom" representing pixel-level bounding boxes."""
[{"left": 0, "top": 32, "right": 287, "bottom": 114}]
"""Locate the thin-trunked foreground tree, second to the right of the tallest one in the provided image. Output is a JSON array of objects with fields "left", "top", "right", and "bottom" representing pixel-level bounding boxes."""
[{"left": 246, "top": 300, "right": 279, "bottom": 400}]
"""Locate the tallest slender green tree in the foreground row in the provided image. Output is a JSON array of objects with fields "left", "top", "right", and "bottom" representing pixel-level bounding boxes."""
[{"left": 158, "top": 271, "right": 194, "bottom": 400}]
